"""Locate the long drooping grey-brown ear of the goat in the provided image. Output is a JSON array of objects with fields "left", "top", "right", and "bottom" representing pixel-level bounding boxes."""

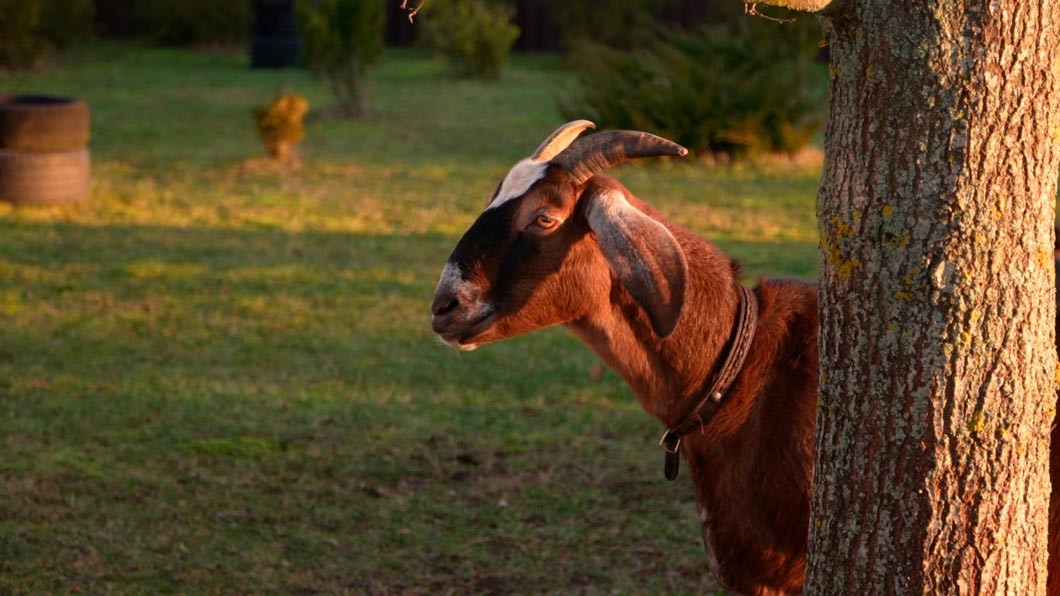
[{"left": 585, "top": 191, "right": 688, "bottom": 337}]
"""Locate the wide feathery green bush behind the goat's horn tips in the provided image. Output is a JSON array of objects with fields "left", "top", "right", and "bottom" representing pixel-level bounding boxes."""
[{"left": 561, "top": 19, "right": 827, "bottom": 158}]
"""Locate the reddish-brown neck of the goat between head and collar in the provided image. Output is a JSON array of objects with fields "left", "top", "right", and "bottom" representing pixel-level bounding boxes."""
[{"left": 569, "top": 230, "right": 739, "bottom": 425}]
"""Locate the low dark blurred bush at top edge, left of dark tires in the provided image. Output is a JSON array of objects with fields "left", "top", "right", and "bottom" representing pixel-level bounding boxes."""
[{"left": 133, "top": 0, "right": 251, "bottom": 46}]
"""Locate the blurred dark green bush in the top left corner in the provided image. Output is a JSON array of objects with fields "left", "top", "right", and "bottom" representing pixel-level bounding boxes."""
[{"left": 0, "top": 0, "right": 94, "bottom": 70}]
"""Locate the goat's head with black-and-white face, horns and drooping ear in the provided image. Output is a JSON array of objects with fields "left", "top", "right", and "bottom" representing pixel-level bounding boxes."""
[{"left": 431, "top": 120, "right": 688, "bottom": 350}]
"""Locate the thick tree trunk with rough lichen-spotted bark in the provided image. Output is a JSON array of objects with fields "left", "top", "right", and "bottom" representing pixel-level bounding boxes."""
[{"left": 806, "top": 0, "right": 1060, "bottom": 595}]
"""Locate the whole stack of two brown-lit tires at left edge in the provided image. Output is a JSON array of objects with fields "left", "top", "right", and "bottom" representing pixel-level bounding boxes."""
[{"left": 0, "top": 93, "right": 91, "bottom": 205}]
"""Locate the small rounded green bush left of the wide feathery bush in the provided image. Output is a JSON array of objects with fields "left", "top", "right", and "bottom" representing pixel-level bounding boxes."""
[{"left": 421, "top": 0, "right": 519, "bottom": 78}]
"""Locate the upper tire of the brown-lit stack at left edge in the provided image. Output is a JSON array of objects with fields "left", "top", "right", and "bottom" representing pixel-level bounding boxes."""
[{"left": 0, "top": 93, "right": 89, "bottom": 153}]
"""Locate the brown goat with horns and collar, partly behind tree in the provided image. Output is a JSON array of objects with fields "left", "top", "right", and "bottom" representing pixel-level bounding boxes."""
[{"left": 431, "top": 121, "right": 1057, "bottom": 594}]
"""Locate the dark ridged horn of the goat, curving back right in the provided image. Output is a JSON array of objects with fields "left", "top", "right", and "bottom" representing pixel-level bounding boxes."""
[{"left": 552, "top": 130, "right": 688, "bottom": 185}]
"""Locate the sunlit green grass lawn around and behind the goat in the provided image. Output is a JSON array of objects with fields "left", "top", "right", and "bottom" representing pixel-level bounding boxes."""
[{"left": 0, "top": 43, "right": 819, "bottom": 595}]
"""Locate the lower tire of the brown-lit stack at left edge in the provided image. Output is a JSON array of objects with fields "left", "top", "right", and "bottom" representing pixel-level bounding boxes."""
[{"left": 0, "top": 148, "right": 92, "bottom": 205}]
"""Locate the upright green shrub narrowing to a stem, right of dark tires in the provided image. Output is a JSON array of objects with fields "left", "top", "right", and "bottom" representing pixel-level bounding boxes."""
[{"left": 295, "top": 0, "right": 386, "bottom": 118}]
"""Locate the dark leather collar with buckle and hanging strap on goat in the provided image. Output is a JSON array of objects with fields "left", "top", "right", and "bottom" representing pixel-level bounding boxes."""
[{"left": 659, "top": 284, "right": 758, "bottom": 480}]
